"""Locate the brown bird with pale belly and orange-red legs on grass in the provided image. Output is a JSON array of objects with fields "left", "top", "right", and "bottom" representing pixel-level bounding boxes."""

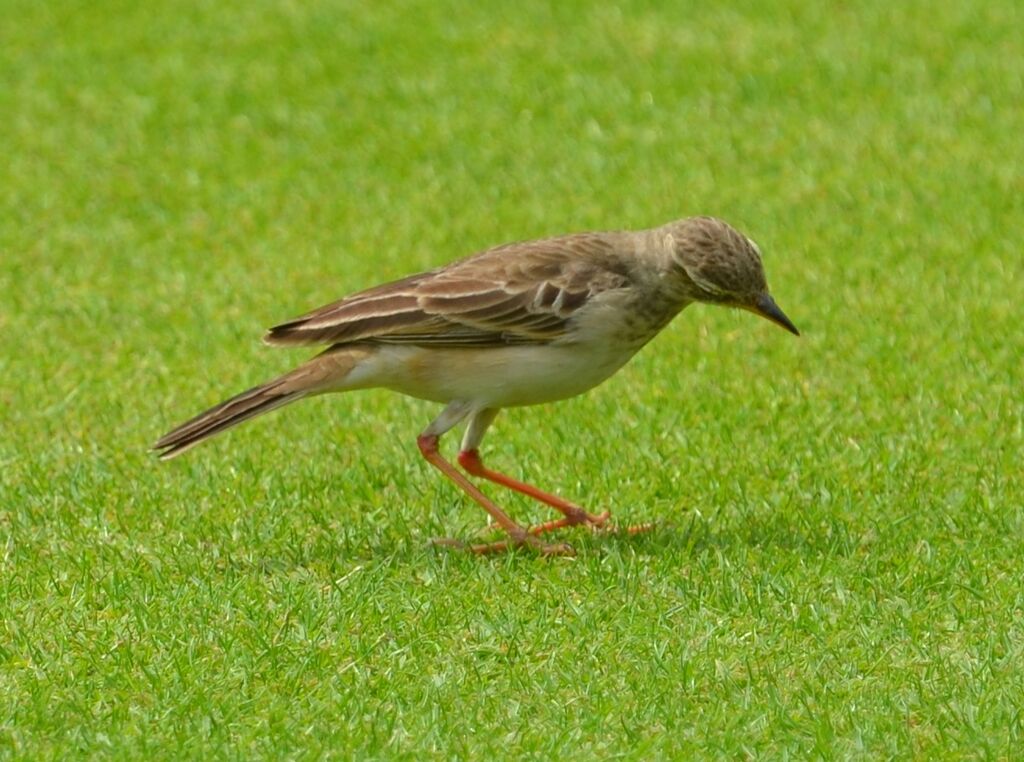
[{"left": 154, "top": 216, "right": 800, "bottom": 555}]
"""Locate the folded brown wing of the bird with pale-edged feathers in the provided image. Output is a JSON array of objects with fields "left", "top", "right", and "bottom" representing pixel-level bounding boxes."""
[{"left": 264, "top": 234, "right": 629, "bottom": 346}]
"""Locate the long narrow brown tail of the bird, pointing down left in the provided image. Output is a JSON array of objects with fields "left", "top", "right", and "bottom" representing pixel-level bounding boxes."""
[{"left": 153, "top": 347, "right": 368, "bottom": 460}]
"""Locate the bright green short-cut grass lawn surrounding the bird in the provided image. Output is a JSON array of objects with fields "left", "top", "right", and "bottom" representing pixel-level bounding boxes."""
[{"left": 0, "top": 0, "right": 1024, "bottom": 759}]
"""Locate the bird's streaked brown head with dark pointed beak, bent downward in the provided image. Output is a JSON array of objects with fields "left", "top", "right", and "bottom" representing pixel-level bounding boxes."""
[{"left": 668, "top": 217, "right": 800, "bottom": 336}]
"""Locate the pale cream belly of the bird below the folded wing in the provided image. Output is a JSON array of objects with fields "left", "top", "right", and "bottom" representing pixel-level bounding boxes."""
[{"left": 356, "top": 344, "right": 635, "bottom": 408}]
